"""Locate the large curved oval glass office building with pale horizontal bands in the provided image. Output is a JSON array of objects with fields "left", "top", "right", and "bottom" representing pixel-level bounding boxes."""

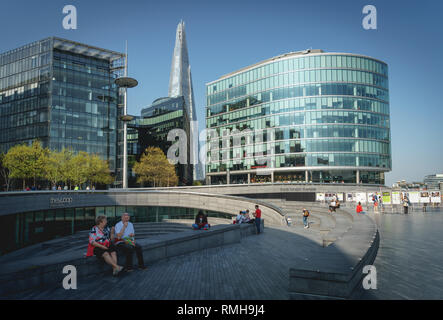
[{"left": 206, "top": 50, "right": 391, "bottom": 184}]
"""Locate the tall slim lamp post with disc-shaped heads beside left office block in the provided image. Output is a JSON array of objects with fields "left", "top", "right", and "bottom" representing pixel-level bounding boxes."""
[{"left": 115, "top": 43, "right": 138, "bottom": 188}]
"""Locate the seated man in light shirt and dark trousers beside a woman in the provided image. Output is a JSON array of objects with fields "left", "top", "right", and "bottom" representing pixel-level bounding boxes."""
[{"left": 115, "top": 212, "right": 146, "bottom": 271}]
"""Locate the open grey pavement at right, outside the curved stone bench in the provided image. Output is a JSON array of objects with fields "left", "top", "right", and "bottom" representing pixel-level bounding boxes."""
[{"left": 361, "top": 209, "right": 443, "bottom": 300}]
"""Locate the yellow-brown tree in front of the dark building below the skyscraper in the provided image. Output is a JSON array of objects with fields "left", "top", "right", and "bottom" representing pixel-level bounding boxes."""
[{"left": 132, "top": 147, "right": 178, "bottom": 187}]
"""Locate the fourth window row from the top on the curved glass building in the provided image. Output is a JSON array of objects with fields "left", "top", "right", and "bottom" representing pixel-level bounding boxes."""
[{"left": 207, "top": 97, "right": 389, "bottom": 119}]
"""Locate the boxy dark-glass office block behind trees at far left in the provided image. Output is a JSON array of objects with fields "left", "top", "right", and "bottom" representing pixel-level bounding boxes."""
[{"left": 0, "top": 37, "right": 124, "bottom": 185}]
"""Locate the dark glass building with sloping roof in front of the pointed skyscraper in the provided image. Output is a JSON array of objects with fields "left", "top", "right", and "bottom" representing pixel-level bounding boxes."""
[{"left": 128, "top": 96, "right": 193, "bottom": 187}]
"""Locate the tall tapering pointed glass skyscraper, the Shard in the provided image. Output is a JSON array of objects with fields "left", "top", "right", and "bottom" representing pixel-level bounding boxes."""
[{"left": 168, "top": 21, "right": 203, "bottom": 180}]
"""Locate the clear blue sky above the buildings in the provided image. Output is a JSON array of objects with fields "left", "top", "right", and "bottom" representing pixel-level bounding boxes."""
[{"left": 0, "top": 0, "right": 443, "bottom": 185}]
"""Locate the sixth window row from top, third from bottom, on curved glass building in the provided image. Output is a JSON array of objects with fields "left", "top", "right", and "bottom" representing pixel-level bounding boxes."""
[{"left": 208, "top": 124, "right": 389, "bottom": 143}]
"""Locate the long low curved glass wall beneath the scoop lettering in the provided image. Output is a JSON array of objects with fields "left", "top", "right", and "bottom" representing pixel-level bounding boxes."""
[{"left": 0, "top": 206, "right": 231, "bottom": 255}]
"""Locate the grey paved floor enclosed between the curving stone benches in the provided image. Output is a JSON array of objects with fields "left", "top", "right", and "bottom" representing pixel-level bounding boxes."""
[{"left": 4, "top": 227, "right": 322, "bottom": 300}]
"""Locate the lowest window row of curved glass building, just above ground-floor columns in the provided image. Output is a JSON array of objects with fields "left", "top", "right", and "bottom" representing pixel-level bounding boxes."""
[{"left": 206, "top": 153, "right": 391, "bottom": 172}]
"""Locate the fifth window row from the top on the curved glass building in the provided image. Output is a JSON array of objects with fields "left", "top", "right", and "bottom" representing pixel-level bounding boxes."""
[{"left": 207, "top": 111, "right": 389, "bottom": 130}]
